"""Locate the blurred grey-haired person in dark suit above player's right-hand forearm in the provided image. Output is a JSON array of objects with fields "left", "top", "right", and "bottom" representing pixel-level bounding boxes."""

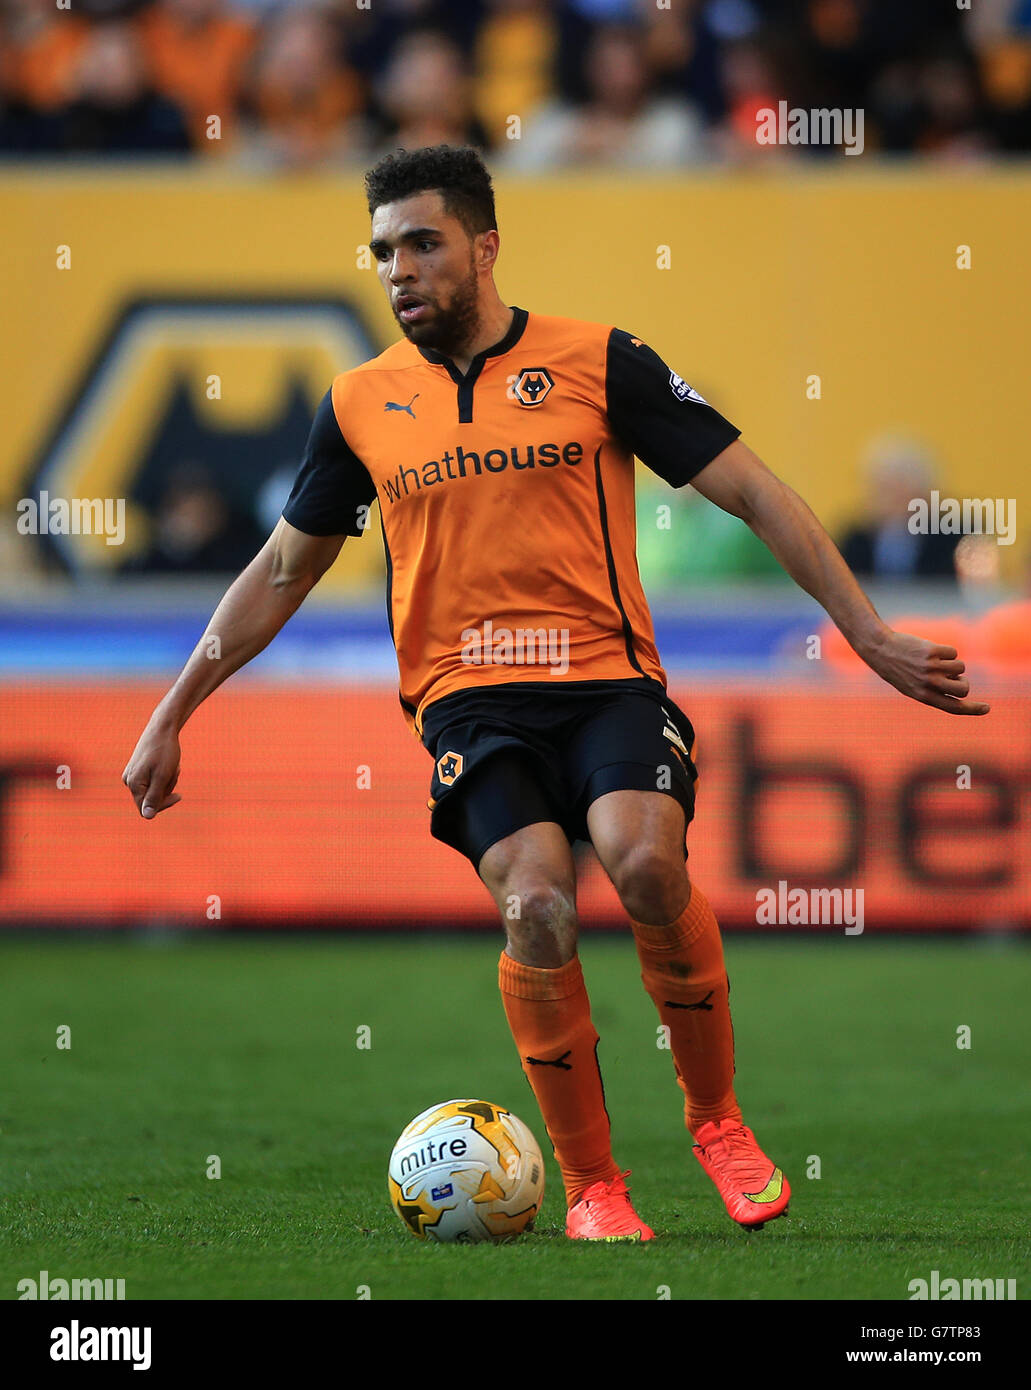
[{"left": 841, "top": 436, "right": 960, "bottom": 582}]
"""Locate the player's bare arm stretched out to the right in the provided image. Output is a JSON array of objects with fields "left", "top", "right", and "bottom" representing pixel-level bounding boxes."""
[{"left": 692, "top": 439, "right": 991, "bottom": 714}]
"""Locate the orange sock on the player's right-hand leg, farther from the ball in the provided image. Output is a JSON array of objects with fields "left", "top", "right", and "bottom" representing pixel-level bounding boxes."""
[{"left": 632, "top": 884, "right": 741, "bottom": 1133}]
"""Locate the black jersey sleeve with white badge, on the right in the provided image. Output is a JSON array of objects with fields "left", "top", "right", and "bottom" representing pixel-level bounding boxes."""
[{"left": 604, "top": 328, "right": 741, "bottom": 488}]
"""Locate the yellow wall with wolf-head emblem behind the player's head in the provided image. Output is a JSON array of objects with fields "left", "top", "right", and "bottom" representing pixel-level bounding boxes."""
[{"left": 0, "top": 167, "right": 1031, "bottom": 588}]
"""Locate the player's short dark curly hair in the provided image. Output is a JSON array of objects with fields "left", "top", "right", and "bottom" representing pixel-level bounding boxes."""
[{"left": 365, "top": 145, "right": 497, "bottom": 236}]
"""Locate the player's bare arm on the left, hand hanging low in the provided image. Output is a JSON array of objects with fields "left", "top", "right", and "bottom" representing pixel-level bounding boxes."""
[{"left": 122, "top": 518, "right": 345, "bottom": 820}]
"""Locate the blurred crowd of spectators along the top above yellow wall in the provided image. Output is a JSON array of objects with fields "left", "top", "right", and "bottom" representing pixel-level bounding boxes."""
[{"left": 0, "top": 0, "right": 1031, "bottom": 170}]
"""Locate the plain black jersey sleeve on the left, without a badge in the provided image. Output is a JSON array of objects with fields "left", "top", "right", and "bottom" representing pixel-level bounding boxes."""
[{"left": 283, "top": 389, "right": 377, "bottom": 535}]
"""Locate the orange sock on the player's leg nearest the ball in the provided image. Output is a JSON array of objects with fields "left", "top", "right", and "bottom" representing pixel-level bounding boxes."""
[{"left": 497, "top": 951, "right": 620, "bottom": 1207}]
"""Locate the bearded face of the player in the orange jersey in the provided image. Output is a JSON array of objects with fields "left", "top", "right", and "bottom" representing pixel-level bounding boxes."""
[{"left": 370, "top": 193, "right": 479, "bottom": 357}]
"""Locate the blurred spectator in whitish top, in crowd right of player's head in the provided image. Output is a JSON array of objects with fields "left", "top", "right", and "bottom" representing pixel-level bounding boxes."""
[{"left": 506, "top": 25, "right": 707, "bottom": 170}]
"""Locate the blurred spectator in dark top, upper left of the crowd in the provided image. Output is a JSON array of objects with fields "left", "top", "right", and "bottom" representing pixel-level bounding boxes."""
[{"left": 57, "top": 19, "right": 190, "bottom": 154}]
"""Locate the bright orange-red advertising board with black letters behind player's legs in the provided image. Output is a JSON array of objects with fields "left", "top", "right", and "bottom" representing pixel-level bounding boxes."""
[{"left": 0, "top": 682, "right": 1031, "bottom": 933}]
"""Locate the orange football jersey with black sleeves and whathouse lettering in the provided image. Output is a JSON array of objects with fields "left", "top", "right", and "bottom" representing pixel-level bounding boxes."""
[{"left": 283, "top": 309, "right": 739, "bottom": 734}]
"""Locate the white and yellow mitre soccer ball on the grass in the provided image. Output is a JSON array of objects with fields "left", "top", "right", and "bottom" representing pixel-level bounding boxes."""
[{"left": 388, "top": 1101, "right": 545, "bottom": 1244}]
